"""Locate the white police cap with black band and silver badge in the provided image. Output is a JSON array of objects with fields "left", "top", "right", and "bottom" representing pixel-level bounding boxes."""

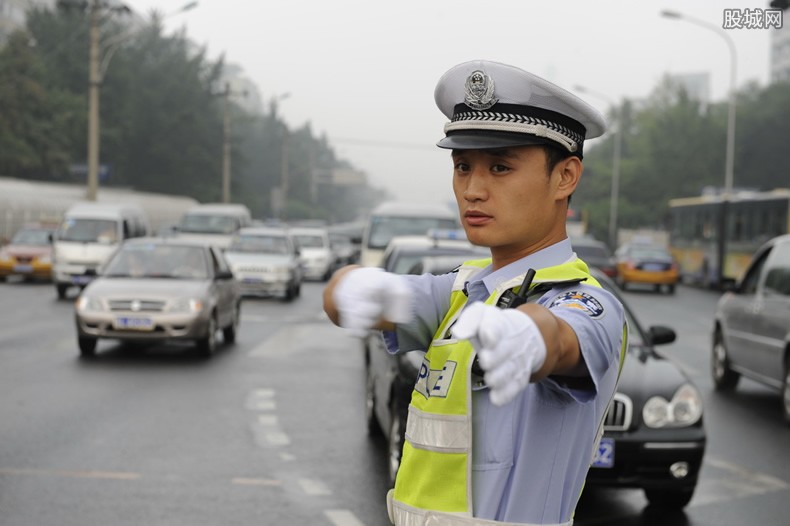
[{"left": 434, "top": 60, "right": 606, "bottom": 157}]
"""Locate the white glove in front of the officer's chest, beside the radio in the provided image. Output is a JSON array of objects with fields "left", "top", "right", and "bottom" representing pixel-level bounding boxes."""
[{"left": 452, "top": 302, "right": 546, "bottom": 405}]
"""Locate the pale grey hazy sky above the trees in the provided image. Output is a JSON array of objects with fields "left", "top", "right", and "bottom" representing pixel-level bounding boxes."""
[{"left": 126, "top": 0, "right": 776, "bottom": 206}]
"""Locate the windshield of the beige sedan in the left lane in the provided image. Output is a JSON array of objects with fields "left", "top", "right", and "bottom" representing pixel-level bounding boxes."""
[{"left": 102, "top": 244, "right": 209, "bottom": 279}]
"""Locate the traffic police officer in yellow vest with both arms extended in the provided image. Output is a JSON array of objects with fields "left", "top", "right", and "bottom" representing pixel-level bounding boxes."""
[{"left": 324, "top": 60, "right": 627, "bottom": 526}]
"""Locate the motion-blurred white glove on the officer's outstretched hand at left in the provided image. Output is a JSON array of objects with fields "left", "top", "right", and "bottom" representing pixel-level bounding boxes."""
[{"left": 332, "top": 267, "right": 412, "bottom": 338}]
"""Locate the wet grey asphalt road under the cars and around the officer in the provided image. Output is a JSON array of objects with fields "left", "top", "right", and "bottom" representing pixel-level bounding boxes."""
[{"left": 0, "top": 283, "right": 790, "bottom": 526}]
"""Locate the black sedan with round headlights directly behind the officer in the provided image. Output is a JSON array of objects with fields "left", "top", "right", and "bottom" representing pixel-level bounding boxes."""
[{"left": 366, "top": 265, "right": 706, "bottom": 508}]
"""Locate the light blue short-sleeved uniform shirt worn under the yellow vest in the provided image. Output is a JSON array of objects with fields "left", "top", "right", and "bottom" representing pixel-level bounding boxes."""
[{"left": 385, "top": 239, "right": 624, "bottom": 524}]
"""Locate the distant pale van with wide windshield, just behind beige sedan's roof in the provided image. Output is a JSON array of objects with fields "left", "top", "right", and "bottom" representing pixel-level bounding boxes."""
[{"left": 177, "top": 203, "right": 252, "bottom": 250}]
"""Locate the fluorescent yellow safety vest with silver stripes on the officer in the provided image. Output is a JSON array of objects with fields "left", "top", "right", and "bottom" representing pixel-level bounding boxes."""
[{"left": 391, "top": 259, "right": 600, "bottom": 526}]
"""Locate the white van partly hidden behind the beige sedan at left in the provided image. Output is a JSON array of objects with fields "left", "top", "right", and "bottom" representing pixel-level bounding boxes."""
[{"left": 52, "top": 203, "right": 150, "bottom": 299}]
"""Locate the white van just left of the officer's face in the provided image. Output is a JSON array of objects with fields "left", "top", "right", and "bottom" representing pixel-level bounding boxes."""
[{"left": 359, "top": 201, "right": 461, "bottom": 267}]
